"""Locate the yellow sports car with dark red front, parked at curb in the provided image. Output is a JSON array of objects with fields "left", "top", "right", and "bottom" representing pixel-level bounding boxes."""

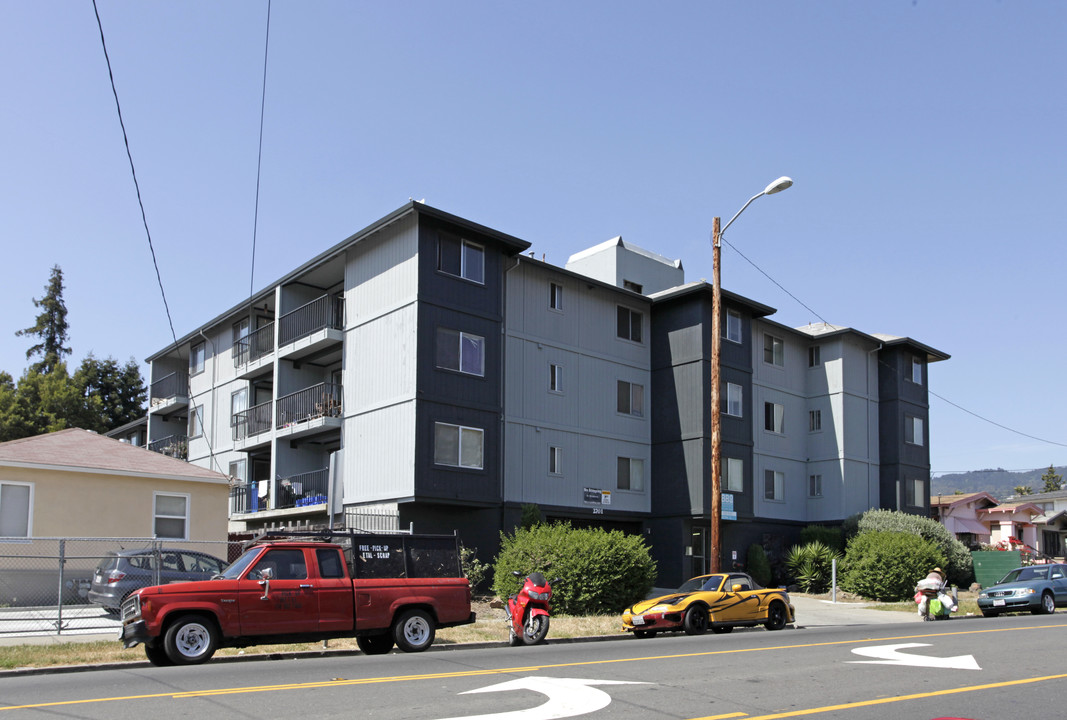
[{"left": 622, "top": 573, "right": 795, "bottom": 638}]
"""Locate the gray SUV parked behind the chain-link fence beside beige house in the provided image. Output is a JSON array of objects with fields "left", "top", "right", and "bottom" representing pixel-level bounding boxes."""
[{"left": 87, "top": 547, "right": 227, "bottom": 614}]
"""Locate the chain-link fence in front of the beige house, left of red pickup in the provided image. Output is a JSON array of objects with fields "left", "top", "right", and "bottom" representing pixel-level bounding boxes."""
[{"left": 0, "top": 538, "right": 242, "bottom": 638}]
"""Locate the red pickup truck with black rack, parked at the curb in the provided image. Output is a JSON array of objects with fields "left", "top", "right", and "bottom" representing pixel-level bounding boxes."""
[{"left": 121, "top": 531, "right": 475, "bottom": 666}]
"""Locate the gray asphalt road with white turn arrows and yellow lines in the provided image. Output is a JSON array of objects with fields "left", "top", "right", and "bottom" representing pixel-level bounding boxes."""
[{"left": 0, "top": 613, "right": 1067, "bottom": 720}]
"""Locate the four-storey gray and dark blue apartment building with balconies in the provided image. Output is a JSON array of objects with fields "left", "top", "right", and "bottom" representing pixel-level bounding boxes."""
[{"left": 147, "top": 203, "right": 947, "bottom": 583}]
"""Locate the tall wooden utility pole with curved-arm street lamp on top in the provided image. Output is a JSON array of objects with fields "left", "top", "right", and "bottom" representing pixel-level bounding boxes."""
[{"left": 711, "top": 176, "right": 793, "bottom": 573}]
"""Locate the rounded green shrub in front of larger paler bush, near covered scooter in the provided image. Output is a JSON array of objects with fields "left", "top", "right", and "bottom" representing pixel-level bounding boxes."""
[{"left": 841, "top": 530, "right": 945, "bottom": 602}]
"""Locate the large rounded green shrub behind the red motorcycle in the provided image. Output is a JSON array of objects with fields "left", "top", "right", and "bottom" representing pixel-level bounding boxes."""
[{"left": 493, "top": 523, "right": 656, "bottom": 615}]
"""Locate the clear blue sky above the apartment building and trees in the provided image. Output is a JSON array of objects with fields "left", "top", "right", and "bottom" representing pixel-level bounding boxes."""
[{"left": 0, "top": 0, "right": 1067, "bottom": 473}]
